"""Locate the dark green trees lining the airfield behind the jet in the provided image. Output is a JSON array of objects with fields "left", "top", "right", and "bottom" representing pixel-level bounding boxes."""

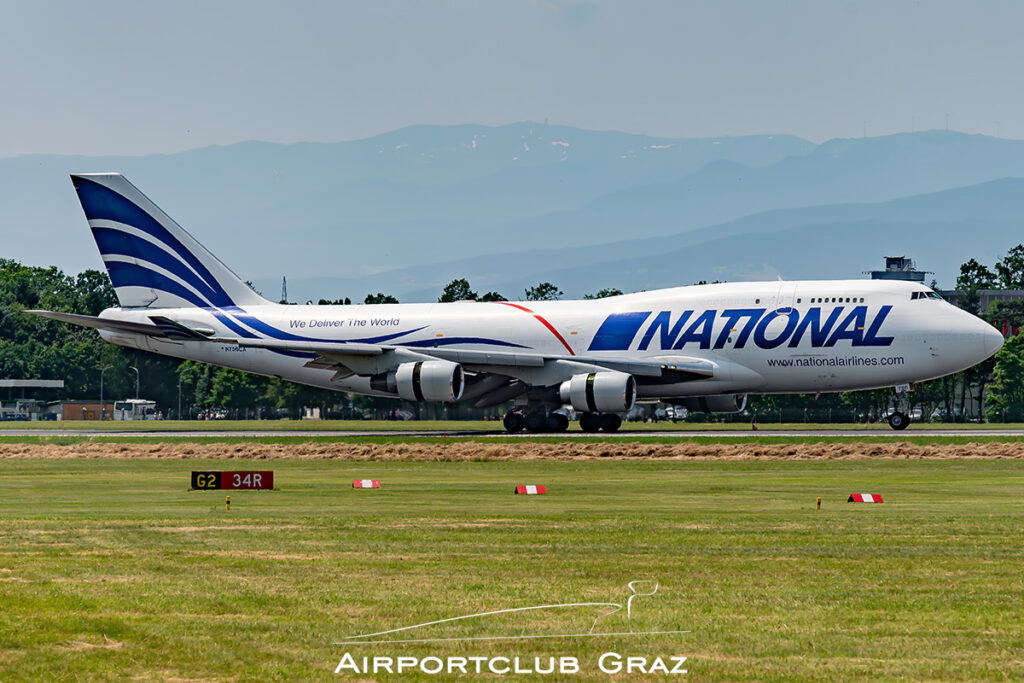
[{"left": 8, "top": 258, "right": 1024, "bottom": 422}]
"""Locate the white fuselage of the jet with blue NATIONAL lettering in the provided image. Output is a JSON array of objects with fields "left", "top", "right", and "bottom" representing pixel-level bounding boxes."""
[{"left": 101, "top": 281, "right": 1001, "bottom": 400}]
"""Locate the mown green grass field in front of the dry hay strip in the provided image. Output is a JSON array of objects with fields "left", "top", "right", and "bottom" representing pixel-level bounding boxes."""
[{"left": 0, "top": 459, "right": 1024, "bottom": 681}]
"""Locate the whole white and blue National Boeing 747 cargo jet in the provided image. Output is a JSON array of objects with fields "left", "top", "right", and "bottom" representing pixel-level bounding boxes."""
[{"left": 31, "top": 173, "right": 1002, "bottom": 432}]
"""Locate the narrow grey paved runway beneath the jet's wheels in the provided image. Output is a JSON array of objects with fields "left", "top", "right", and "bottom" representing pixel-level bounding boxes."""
[{"left": 0, "top": 428, "right": 1024, "bottom": 440}]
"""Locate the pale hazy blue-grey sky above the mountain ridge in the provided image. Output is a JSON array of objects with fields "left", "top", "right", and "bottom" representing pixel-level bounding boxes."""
[{"left": 0, "top": 0, "right": 1024, "bottom": 157}]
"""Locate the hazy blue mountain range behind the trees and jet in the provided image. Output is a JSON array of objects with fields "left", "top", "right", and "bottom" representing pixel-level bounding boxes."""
[{"left": 0, "top": 123, "right": 1024, "bottom": 301}]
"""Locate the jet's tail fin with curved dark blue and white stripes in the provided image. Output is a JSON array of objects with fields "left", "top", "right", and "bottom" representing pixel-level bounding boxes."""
[{"left": 71, "top": 173, "right": 269, "bottom": 308}]
